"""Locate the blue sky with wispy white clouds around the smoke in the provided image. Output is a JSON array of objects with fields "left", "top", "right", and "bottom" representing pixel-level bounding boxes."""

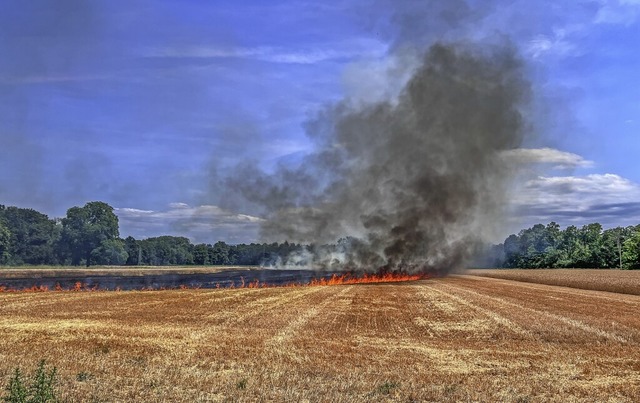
[{"left": 0, "top": 0, "right": 640, "bottom": 243}]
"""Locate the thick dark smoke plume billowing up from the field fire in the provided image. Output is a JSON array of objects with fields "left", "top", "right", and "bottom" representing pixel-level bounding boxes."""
[{"left": 228, "top": 44, "right": 530, "bottom": 272}]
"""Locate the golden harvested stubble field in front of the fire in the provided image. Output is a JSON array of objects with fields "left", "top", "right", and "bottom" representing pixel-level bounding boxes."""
[{"left": 0, "top": 275, "right": 640, "bottom": 402}]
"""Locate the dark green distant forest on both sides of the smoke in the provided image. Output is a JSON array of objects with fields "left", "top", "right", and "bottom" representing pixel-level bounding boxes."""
[{"left": 0, "top": 201, "right": 640, "bottom": 269}]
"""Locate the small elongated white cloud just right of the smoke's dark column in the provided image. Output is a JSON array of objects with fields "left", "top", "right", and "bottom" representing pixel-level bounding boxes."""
[{"left": 502, "top": 147, "right": 593, "bottom": 169}]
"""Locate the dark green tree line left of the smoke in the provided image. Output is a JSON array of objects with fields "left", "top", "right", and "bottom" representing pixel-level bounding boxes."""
[{"left": 0, "top": 201, "right": 303, "bottom": 266}]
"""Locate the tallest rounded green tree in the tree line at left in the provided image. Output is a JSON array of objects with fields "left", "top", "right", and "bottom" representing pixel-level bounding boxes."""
[{"left": 62, "top": 201, "right": 119, "bottom": 267}]
